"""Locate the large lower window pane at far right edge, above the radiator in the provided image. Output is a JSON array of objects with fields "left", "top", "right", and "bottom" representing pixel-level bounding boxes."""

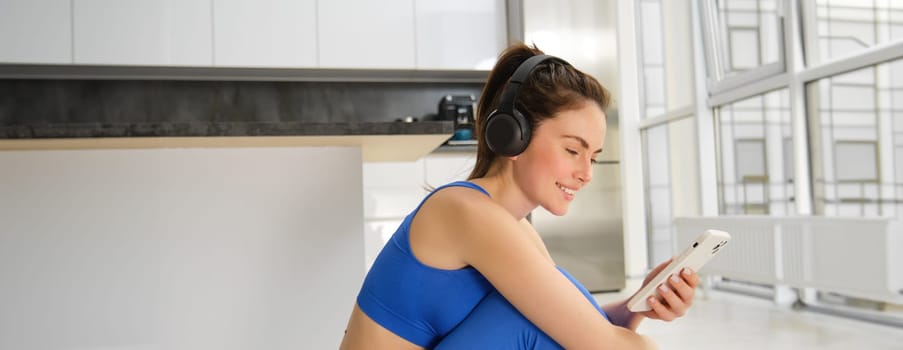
[{"left": 807, "top": 59, "right": 903, "bottom": 217}]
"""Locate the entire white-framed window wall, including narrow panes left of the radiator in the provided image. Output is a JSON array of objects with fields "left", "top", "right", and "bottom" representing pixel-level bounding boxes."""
[{"left": 619, "top": 0, "right": 903, "bottom": 316}]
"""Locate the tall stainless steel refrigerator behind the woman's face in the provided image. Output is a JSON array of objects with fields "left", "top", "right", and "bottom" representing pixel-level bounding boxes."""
[{"left": 520, "top": 0, "right": 626, "bottom": 292}]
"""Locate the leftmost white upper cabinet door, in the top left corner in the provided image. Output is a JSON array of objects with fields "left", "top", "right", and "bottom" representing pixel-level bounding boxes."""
[{"left": 0, "top": 0, "right": 72, "bottom": 63}]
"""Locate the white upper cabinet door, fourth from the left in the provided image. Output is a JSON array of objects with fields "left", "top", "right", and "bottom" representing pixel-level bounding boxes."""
[{"left": 317, "top": 0, "right": 415, "bottom": 69}]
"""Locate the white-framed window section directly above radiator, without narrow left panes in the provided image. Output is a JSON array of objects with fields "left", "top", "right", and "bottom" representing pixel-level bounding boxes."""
[{"left": 699, "top": 0, "right": 903, "bottom": 314}]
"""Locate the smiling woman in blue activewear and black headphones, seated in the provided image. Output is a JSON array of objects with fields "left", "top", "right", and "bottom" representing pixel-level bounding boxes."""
[{"left": 341, "top": 44, "right": 698, "bottom": 349}]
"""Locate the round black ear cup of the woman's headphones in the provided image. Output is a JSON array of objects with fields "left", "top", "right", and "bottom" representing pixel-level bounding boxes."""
[{"left": 485, "top": 110, "right": 531, "bottom": 157}]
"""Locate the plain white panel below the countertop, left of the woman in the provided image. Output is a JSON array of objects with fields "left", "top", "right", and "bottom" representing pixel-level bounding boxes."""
[{"left": 0, "top": 147, "right": 364, "bottom": 350}]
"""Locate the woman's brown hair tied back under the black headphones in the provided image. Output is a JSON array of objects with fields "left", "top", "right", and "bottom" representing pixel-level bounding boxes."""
[{"left": 467, "top": 43, "right": 611, "bottom": 180}]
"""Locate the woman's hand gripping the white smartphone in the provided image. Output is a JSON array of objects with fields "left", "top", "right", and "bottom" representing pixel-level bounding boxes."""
[{"left": 640, "top": 258, "right": 699, "bottom": 321}]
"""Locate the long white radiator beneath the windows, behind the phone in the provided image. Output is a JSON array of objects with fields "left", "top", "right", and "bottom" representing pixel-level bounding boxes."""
[{"left": 674, "top": 216, "right": 903, "bottom": 303}]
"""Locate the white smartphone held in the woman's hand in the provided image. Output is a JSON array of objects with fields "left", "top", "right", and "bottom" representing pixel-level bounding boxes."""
[{"left": 627, "top": 230, "right": 731, "bottom": 312}]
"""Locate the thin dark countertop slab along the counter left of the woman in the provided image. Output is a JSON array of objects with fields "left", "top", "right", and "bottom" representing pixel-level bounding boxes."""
[{"left": 0, "top": 121, "right": 454, "bottom": 139}]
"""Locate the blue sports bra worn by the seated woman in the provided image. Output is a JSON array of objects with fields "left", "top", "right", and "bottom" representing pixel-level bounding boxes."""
[{"left": 357, "top": 181, "right": 492, "bottom": 348}]
